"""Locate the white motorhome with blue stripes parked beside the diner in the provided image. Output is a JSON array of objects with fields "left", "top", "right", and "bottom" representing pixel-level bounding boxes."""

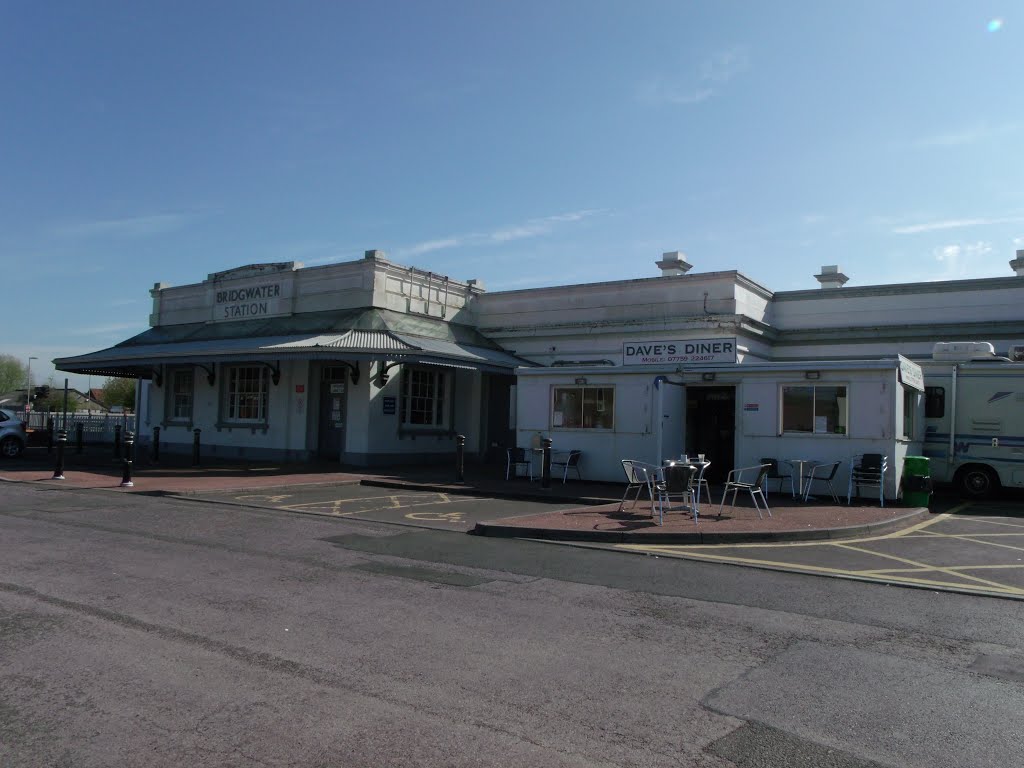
[{"left": 920, "top": 342, "right": 1024, "bottom": 499}]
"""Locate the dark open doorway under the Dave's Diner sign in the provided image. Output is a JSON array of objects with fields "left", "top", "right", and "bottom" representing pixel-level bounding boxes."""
[{"left": 686, "top": 386, "right": 736, "bottom": 482}]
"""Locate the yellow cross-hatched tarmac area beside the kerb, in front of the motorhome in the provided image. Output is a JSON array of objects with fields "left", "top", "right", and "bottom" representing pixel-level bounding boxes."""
[{"left": 615, "top": 502, "right": 1024, "bottom": 599}]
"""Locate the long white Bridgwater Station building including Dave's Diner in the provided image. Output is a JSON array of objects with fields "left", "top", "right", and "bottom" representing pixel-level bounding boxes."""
[{"left": 54, "top": 246, "right": 1024, "bottom": 497}]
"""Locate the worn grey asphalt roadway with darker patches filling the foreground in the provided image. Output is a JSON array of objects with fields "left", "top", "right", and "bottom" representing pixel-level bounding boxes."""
[{"left": 0, "top": 483, "right": 1024, "bottom": 768}]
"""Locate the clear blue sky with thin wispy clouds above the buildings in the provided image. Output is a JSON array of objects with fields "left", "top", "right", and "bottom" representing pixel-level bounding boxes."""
[{"left": 0, "top": 0, "right": 1024, "bottom": 386}]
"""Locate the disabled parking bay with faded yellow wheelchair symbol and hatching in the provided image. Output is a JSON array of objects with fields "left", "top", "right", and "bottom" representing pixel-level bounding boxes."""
[{"left": 200, "top": 484, "right": 579, "bottom": 531}]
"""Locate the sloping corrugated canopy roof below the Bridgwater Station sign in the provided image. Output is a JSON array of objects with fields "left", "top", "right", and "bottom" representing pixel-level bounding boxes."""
[{"left": 53, "top": 307, "right": 534, "bottom": 379}]
